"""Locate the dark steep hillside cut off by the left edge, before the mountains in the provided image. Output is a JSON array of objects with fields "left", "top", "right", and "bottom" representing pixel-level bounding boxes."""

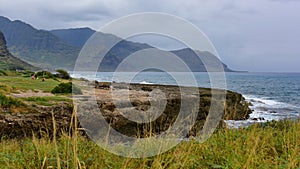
[{"left": 0, "top": 31, "right": 36, "bottom": 70}]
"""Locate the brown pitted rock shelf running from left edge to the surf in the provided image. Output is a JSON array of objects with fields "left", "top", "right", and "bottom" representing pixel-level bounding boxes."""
[{"left": 0, "top": 83, "right": 251, "bottom": 137}]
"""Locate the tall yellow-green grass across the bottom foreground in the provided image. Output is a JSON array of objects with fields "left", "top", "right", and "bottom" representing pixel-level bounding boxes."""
[{"left": 0, "top": 121, "right": 300, "bottom": 169}]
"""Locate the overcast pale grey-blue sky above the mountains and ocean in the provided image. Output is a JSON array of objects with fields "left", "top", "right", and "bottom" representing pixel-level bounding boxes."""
[{"left": 0, "top": 0, "right": 300, "bottom": 72}]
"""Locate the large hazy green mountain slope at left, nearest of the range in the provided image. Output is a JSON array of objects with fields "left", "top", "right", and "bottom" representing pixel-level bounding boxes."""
[{"left": 0, "top": 16, "right": 80, "bottom": 69}]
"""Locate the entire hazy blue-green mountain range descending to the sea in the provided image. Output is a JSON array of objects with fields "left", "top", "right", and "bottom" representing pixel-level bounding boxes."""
[{"left": 0, "top": 16, "right": 232, "bottom": 72}]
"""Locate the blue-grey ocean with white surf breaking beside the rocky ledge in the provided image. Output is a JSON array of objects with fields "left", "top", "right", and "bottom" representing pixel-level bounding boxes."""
[{"left": 71, "top": 72, "right": 300, "bottom": 128}]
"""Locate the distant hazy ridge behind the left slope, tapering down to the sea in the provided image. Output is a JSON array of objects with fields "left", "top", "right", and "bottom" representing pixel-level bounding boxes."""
[{"left": 51, "top": 28, "right": 232, "bottom": 72}]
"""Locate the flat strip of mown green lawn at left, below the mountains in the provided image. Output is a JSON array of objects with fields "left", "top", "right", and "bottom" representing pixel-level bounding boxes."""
[{"left": 0, "top": 76, "right": 60, "bottom": 92}]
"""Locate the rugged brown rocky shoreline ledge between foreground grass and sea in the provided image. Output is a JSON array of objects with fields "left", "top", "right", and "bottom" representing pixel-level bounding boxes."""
[{"left": 0, "top": 82, "right": 251, "bottom": 138}]
